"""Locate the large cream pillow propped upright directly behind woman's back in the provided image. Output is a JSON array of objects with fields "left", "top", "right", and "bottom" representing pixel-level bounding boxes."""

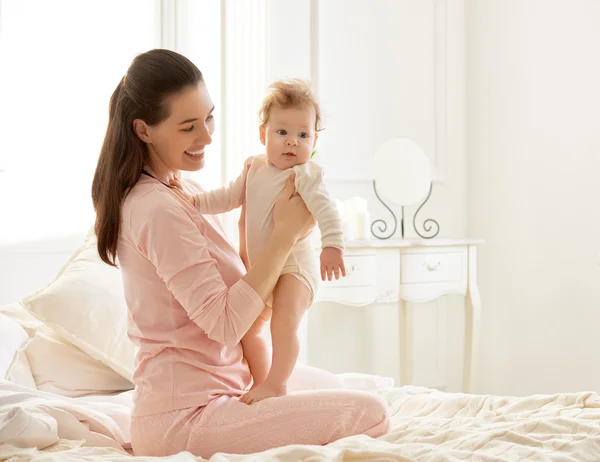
[{"left": 22, "top": 234, "right": 136, "bottom": 380}]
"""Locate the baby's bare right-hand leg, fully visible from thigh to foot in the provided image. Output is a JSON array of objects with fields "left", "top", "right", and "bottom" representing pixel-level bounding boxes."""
[{"left": 244, "top": 274, "right": 311, "bottom": 404}]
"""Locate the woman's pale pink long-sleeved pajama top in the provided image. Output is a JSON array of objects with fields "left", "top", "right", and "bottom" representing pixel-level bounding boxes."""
[{"left": 117, "top": 175, "right": 264, "bottom": 416}]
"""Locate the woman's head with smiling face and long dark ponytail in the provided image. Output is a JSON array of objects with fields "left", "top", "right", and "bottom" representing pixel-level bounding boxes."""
[{"left": 92, "top": 49, "right": 214, "bottom": 266}]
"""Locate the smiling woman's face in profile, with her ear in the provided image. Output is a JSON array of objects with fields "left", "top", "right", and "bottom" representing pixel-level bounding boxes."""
[{"left": 134, "top": 82, "right": 215, "bottom": 177}]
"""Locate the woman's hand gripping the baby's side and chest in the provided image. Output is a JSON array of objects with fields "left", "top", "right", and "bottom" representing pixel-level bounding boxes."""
[{"left": 273, "top": 174, "right": 317, "bottom": 242}]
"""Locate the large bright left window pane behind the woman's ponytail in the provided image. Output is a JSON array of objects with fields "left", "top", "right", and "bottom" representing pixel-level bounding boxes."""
[{"left": 0, "top": 0, "right": 161, "bottom": 244}]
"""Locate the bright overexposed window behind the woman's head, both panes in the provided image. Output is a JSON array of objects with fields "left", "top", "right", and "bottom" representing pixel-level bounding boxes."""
[{"left": 0, "top": 0, "right": 272, "bottom": 245}]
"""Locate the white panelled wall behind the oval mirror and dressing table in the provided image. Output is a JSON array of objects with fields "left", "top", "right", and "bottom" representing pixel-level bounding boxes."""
[{"left": 300, "top": 0, "right": 466, "bottom": 390}]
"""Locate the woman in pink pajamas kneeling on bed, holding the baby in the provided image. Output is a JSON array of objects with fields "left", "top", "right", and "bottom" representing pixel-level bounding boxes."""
[{"left": 92, "top": 50, "right": 389, "bottom": 458}]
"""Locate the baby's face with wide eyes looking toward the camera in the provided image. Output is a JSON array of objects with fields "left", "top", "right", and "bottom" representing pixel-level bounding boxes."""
[{"left": 260, "top": 106, "right": 318, "bottom": 170}]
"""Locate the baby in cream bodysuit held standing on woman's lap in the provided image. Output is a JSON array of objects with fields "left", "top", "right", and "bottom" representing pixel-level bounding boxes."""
[{"left": 194, "top": 80, "right": 346, "bottom": 404}]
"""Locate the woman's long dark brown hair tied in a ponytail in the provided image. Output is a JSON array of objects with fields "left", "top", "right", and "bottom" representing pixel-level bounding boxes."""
[{"left": 92, "top": 49, "right": 203, "bottom": 266}]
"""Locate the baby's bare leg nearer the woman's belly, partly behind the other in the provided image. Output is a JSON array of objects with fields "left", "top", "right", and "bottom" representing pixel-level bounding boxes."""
[{"left": 241, "top": 307, "right": 271, "bottom": 402}]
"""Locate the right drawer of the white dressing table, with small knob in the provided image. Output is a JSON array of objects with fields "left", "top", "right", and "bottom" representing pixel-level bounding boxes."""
[{"left": 400, "top": 252, "right": 466, "bottom": 284}]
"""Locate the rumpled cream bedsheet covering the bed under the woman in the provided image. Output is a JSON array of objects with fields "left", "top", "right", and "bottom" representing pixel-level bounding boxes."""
[{"left": 0, "top": 381, "right": 600, "bottom": 462}]
